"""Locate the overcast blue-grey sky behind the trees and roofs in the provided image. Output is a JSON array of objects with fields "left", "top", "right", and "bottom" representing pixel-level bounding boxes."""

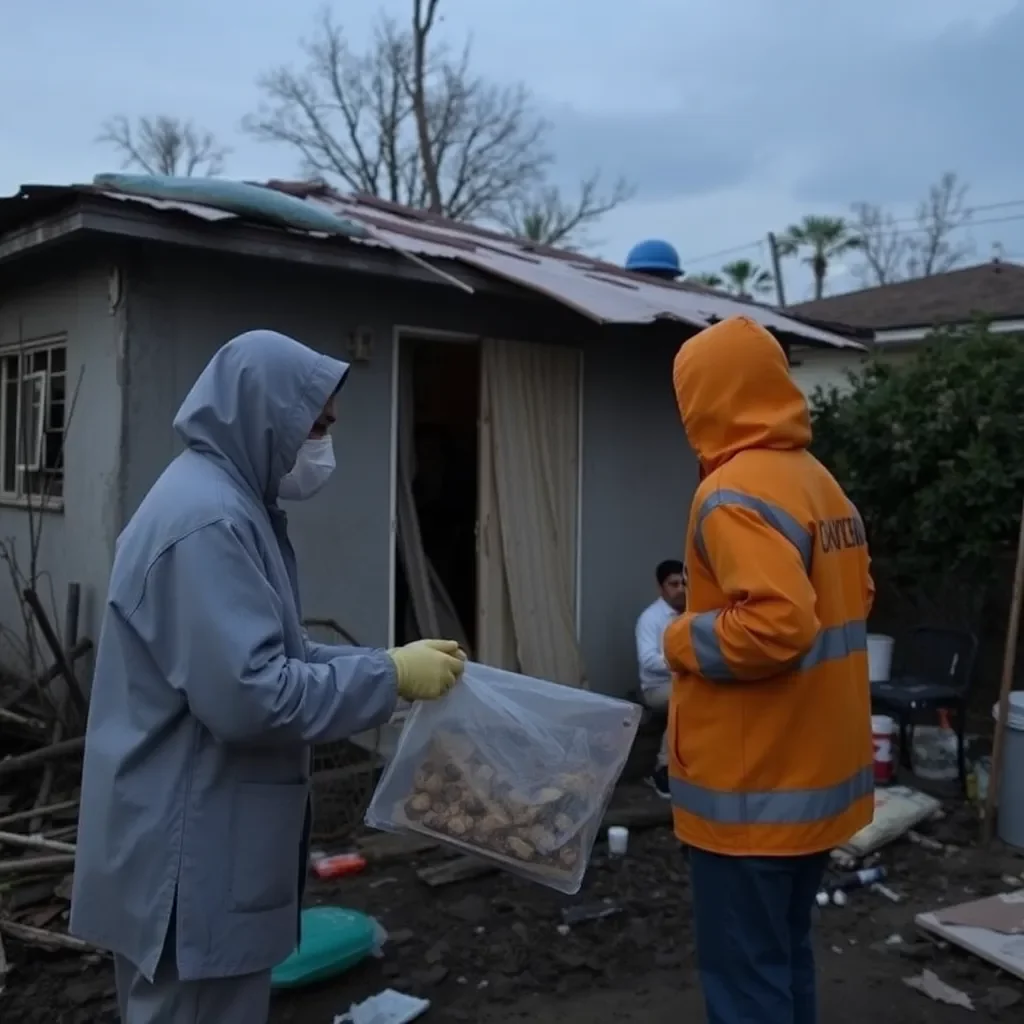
[{"left": 0, "top": 0, "right": 1024, "bottom": 301}]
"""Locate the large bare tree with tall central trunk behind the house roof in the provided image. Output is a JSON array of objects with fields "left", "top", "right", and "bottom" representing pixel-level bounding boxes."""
[{"left": 244, "top": 0, "right": 631, "bottom": 241}]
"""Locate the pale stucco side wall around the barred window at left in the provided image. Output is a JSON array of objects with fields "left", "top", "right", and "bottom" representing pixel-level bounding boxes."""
[{"left": 0, "top": 245, "right": 122, "bottom": 670}]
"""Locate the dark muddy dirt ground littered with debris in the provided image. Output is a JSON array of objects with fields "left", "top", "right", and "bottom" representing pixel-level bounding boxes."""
[{"left": 0, "top": 795, "right": 1024, "bottom": 1024}]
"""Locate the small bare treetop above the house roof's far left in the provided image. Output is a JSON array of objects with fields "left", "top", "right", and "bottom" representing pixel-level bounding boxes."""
[{"left": 96, "top": 115, "right": 230, "bottom": 177}]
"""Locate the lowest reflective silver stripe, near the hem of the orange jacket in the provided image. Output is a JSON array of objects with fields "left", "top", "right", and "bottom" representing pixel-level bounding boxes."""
[{"left": 669, "top": 766, "right": 874, "bottom": 825}]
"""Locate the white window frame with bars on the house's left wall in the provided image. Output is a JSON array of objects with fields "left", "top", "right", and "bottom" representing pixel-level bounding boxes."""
[{"left": 0, "top": 334, "right": 70, "bottom": 511}]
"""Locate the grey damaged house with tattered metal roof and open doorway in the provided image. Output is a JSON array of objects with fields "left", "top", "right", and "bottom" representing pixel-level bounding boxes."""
[{"left": 0, "top": 178, "right": 859, "bottom": 693}]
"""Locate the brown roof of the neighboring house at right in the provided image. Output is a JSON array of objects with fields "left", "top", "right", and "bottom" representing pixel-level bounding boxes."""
[{"left": 786, "top": 261, "right": 1024, "bottom": 331}]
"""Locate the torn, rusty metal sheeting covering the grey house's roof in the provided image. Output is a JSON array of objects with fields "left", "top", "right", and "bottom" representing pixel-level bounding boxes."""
[{"left": 79, "top": 175, "right": 863, "bottom": 349}]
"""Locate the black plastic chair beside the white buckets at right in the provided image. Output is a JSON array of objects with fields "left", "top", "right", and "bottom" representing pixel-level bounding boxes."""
[{"left": 871, "top": 626, "right": 978, "bottom": 792}]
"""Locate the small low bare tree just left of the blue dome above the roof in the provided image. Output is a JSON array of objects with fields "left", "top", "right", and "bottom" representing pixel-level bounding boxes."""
[{"left": 496, "top": 173, "right": 634, "bottom": 249}]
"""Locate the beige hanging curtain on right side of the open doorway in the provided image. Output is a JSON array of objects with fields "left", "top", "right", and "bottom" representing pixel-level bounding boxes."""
[{"left": 480, "top": 339, "right": 586, "bottom": 686}]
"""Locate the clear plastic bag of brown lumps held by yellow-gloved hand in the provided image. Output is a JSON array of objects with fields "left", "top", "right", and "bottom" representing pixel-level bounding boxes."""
[{"left": 366, "top": 663, "right": 641, "bottom": 895}]
